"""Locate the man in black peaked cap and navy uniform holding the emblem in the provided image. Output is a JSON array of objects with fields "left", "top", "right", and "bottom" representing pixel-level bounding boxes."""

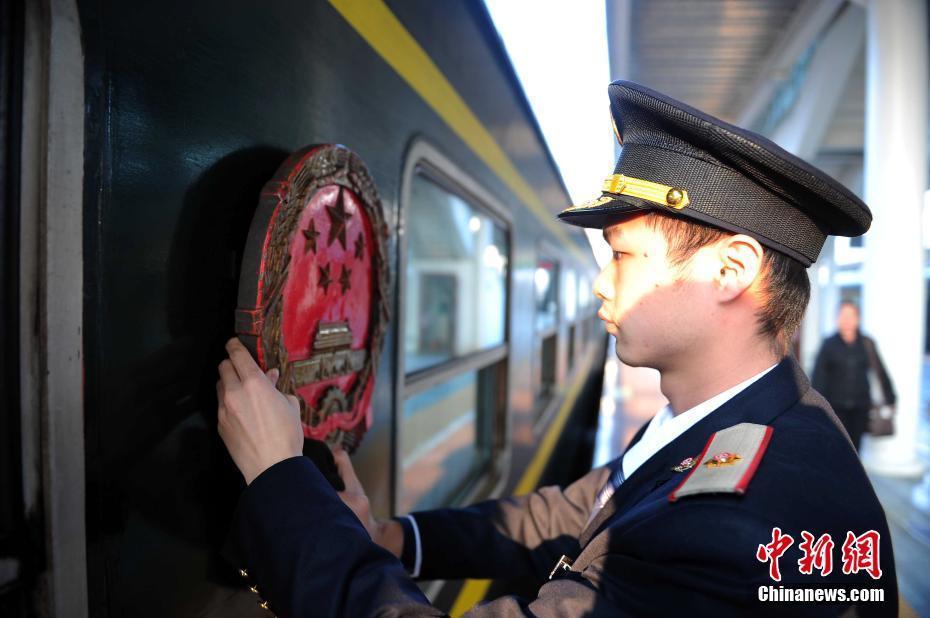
[{"left": 217, "top": 81, "right": 898, "bottom": 617}]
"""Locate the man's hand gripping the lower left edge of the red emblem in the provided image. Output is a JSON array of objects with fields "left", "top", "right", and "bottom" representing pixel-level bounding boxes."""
[{"left": 216, "top": 337, "right": 304, "bottom": 484}]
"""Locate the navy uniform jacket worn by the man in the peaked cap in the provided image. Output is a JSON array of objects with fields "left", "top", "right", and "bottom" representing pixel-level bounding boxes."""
[{"left": 225, "top": 358, "right": 898, "bottom": 618}]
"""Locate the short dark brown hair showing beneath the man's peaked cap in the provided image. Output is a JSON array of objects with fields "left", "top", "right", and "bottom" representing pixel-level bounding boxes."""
[{"left": 645, "top": 212, "right": 811, "bottom": 355}]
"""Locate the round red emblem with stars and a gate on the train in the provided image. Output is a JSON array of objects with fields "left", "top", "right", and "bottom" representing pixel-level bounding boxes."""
[{"left": 236, "top": 145, "right": 389, "bottom": 452}]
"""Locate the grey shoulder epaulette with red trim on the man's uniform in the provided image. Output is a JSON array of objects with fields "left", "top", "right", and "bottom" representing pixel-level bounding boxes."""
[{"left": 668, "top": 423, "right": 772, "bottom": 502}]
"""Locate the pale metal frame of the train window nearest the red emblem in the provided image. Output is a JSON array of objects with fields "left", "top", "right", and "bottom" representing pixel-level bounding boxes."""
[{"left": 390, "top": 137, "right": 514, "bottom": 513}]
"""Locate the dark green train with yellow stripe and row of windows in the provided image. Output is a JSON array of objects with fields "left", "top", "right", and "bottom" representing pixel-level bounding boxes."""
[{"left": 0, "top": 0, "right": 607, "bottom": 618}]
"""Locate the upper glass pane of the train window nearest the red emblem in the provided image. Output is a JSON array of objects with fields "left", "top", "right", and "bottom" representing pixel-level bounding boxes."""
[{"left": 404, "top": 173, "right": 509, "bottom": 373}]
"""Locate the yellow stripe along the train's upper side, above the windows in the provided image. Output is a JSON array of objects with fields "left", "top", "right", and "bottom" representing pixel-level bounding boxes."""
[{"left": 330, "top": 0, "right": 590, "bottom": 260}]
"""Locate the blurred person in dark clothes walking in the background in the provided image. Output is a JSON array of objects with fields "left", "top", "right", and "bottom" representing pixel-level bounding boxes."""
[{"left": 812, "top": 301, "right": 896, "bottom": 451}]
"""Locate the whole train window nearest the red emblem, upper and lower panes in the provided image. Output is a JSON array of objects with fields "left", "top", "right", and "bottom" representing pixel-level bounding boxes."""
[{"left": 396, "top": 165, "right": 510, "bottom": 512}]
